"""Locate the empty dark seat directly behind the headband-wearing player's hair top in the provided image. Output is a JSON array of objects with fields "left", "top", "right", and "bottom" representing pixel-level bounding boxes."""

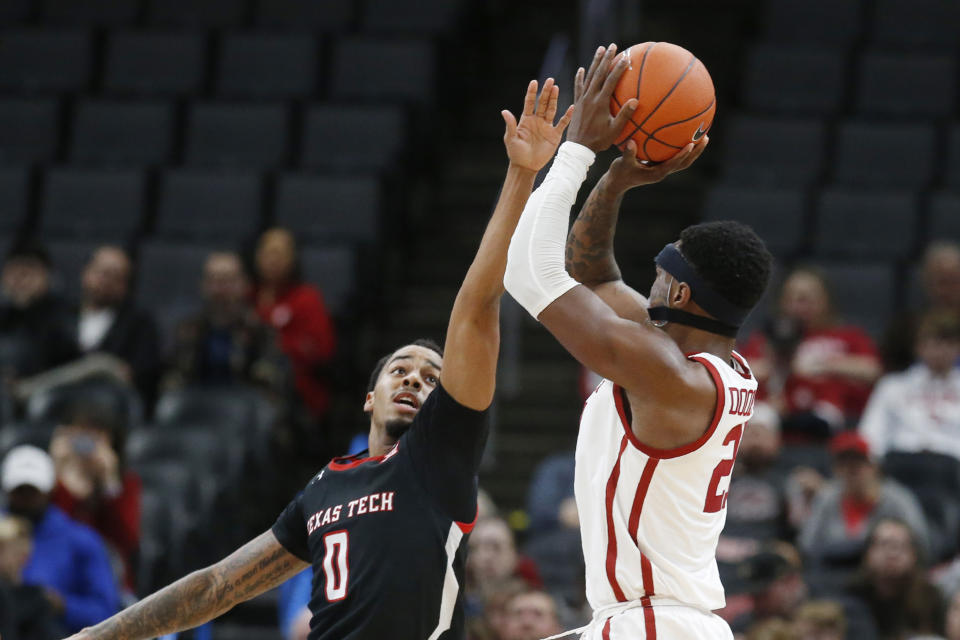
[{"left": 703, "top": 185, "right": 807, "bottom": 256}]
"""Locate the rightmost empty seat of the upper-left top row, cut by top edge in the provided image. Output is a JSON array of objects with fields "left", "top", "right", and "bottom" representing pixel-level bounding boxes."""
[{"left": 361, "top": 0, "right": 463, "bottom": 34}]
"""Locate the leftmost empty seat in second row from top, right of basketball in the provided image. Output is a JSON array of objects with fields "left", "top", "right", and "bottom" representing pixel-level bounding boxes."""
[{"left": 743, "top": 44, "right": 845, "bottom": 114}]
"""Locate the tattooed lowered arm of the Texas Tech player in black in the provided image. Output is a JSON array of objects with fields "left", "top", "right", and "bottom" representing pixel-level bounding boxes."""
[{"left": 81, "top": 531, "right": 308, "bottom": 640}]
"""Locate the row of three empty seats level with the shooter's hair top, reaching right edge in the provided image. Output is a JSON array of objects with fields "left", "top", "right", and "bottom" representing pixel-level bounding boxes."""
[{"left": 703, "top": 186, "right": 960, "bottom": 260}]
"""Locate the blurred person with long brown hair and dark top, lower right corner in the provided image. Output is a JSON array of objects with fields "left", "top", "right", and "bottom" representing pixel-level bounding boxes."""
[{"left": 849, "top": 518, "right": 944, "bottom": 640}]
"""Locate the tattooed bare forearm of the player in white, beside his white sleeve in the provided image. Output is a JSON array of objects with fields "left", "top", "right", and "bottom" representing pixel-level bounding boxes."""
[{"left": 566, "top": 178, "right": 623, "bottom": 285}]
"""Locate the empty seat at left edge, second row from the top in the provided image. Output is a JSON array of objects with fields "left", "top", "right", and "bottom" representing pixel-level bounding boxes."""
[{"left": 0, "top": 29, "right": 91, "bottom": 92}]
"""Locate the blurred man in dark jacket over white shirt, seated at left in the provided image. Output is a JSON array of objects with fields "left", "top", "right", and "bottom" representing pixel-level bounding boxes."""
[{"left": 77, "top": 245, "right": 160, "bottom": 407}]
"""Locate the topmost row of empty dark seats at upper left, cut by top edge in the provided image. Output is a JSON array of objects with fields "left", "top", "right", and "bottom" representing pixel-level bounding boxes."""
[{"left": 0, "top": 0, "right": 462, "bottom": 33}]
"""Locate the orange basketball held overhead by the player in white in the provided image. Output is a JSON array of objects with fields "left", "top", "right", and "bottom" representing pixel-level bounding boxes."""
[{"left": 610, "top": 42, "right": 717, "bottom": 162}]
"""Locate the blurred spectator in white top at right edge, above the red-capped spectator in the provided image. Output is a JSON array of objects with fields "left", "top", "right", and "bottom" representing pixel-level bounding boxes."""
[{"left": 860, "top": 311, "right": 960, "bottom": 460}]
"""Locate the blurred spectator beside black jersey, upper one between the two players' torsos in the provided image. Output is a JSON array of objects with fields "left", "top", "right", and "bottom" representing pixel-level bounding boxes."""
[{"left": 467, "top": 517, "right": 543, "bottom": 600}]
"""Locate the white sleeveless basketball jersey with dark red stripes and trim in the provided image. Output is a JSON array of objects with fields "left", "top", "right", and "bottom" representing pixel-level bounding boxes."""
[{"left": 575, "top": 353, "right": 757, "bottom": 611}]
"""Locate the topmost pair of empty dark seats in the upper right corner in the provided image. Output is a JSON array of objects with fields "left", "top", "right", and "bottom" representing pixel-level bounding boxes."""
[{"left": 764, "top": 0, "right": 960, "bottom": 50}]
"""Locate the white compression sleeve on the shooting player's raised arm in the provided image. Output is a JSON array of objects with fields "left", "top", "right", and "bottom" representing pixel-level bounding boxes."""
[{"left": 503, "top": 142, "right": 596, "bottom": 318}]
